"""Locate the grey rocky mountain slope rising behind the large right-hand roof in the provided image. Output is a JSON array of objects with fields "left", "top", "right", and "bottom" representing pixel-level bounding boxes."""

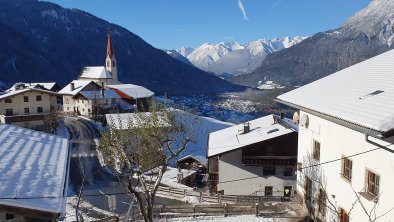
[{"left": 230, "top": 0, "right": 394, "bottom": 86}]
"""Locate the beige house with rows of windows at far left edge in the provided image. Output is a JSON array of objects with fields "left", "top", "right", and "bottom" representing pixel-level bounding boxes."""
[{"left": 0, "top": 83, "right": 58, "bottom": 130}]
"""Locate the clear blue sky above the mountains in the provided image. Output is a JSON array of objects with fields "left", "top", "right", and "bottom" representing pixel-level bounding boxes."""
[{"left": 44, "top": 0, "right": 370, "bottom": 49}]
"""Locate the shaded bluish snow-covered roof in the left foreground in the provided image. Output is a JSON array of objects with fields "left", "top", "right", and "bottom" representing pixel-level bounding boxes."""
[{"left": 0, "top": 124, "right": 69, "bottom": 216}]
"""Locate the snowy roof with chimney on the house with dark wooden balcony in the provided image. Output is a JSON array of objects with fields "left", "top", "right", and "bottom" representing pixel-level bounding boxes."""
[{"left": 208, "top": 114, "right": 298, "bottom": 157}]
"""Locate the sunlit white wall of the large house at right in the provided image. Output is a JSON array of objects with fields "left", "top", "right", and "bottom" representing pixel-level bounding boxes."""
[{"left": 298, "top": 111, "right": 394, "bottom": 222}]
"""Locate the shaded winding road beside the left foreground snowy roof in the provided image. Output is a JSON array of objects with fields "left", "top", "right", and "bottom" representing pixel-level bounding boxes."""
[{"left": 64, "top": 117, "right": 129, "bottom": 216}]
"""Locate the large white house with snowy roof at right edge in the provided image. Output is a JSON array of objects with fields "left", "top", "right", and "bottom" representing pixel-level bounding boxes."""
[{"left": 277, "top": 50, "right": 394, "bottom": 222}]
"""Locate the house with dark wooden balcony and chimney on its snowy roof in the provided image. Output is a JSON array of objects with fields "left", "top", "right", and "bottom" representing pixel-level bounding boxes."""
[{"left": 207, "top": 115, "right": 298, "bottom": 197}]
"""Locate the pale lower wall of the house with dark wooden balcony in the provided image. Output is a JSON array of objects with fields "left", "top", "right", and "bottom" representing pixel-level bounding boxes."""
[{"left": 218, "top": 149, "right": 296, "bottom": 196}]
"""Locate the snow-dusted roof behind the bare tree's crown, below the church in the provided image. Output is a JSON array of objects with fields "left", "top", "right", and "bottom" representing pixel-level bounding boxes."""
[{"left": 105, "top": 112, "right": 170, "bottom": 130}]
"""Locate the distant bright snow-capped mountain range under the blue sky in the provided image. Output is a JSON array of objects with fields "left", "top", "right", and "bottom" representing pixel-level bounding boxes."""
[{"left": 176, "top": 36, "right": 306, "bottom": 75}]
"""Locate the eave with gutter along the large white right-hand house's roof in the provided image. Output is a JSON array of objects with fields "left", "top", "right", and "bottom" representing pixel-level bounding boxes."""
[{"left": 275, "top": 98, "right": 384, "bottom": 139}]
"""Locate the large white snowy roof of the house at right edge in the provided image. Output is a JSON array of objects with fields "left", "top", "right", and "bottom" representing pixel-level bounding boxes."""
[{"left": 278, "top": 50, "right": 394, "bottom": 132}]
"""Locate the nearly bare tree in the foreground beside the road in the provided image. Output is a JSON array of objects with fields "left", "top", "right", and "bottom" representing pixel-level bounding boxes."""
[{"left": 99, "top": 101, "right": 190, "bottom": 221}]
